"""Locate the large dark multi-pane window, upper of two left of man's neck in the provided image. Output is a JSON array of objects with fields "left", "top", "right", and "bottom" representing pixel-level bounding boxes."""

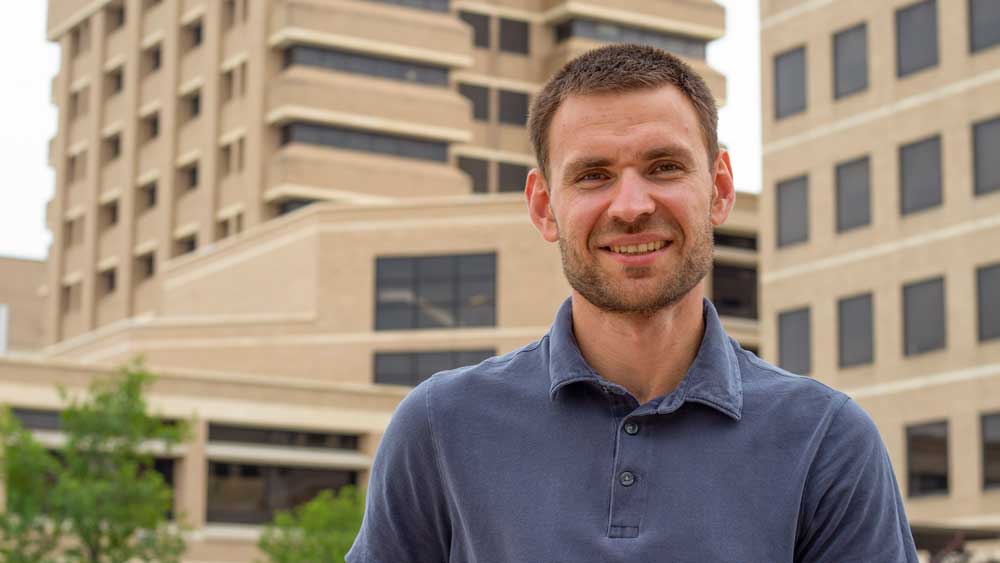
[{"left": 375, "top": 253, "right": 496, "bottom": 330}]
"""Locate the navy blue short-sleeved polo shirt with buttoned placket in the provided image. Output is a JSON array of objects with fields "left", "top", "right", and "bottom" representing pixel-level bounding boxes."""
[{"left": 347, "top": 300, "right": 917, "bottom": 563}]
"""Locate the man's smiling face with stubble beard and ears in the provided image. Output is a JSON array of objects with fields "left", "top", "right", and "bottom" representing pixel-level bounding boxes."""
[{"left": 529, "top": 86, "right": 732, "bottom": 316}]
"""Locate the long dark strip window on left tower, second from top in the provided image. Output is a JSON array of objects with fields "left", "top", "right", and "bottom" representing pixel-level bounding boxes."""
[{"left": 284, "top": 45, "right": 448, "bottom": 86}]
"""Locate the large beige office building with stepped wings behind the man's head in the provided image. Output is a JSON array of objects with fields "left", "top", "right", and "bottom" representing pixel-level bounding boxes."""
[{"left": 0, "top": 0, "right": 761, "bottom": 562}]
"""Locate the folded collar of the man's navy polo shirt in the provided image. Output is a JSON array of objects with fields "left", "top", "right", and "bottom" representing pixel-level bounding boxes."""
[{"left": 549, "top": 298, "right": 743, "bottom": 420}]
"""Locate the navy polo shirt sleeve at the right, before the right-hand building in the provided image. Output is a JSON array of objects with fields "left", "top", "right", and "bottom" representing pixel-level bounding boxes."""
[{"left": 795, "top": 399, "right": 918, "bottom": 563}]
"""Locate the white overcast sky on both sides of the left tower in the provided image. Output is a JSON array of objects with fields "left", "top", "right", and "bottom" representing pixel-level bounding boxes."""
[{"left": 0, "top": 0, "right": 761, "bottom": 264}]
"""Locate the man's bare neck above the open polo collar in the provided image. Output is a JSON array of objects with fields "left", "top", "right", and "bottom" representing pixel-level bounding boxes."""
[{"left": 573, "top": 284, "right": 705, "bottom": 404}]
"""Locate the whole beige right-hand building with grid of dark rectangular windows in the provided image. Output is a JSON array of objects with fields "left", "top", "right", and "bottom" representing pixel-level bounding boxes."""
[{"left": 760, "top": 0, "right": 1000, "bottom": 556}]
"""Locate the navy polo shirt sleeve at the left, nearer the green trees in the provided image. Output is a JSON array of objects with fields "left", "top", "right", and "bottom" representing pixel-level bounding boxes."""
[{"left": 346, "top": 379, "right": 451, "bottom": 563}]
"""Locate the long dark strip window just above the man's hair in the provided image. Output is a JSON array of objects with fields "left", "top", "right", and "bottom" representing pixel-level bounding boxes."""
[{"left": 554, "top": 19, "right": 708, "bottom": 60}]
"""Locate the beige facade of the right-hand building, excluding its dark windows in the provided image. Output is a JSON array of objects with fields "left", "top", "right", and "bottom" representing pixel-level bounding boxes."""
[{"left": 760, "top": 0, "right": 1000, "bottom": 552}]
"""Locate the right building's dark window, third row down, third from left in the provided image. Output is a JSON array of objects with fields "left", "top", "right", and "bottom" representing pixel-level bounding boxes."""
[{"left": 903, "top": 278, "right": 947, "bottom": 356}]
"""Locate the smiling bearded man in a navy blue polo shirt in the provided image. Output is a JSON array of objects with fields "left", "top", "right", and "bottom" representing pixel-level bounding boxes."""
[{"left": 347, "top": 45, "right": 917, "bottom": 563}]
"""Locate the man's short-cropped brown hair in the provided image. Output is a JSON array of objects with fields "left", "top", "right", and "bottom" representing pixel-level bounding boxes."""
[{"left": 528, "top": 44, "right": 719, "bottom": 180}]
